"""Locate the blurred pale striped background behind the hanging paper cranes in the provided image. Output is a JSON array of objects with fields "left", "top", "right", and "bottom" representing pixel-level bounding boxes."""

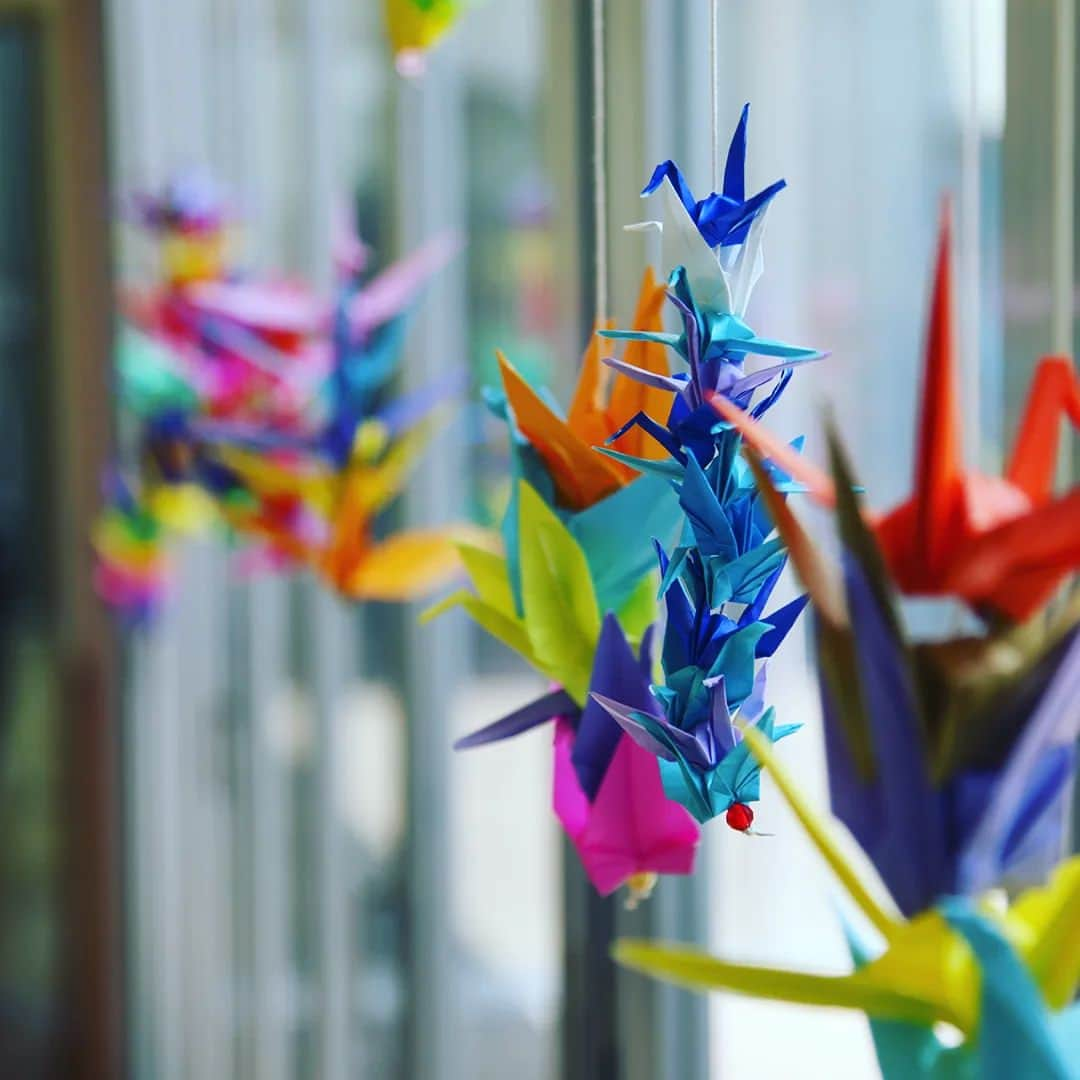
[{"left": 0, "top": 0, "right": 1076, "bottom": 1080}]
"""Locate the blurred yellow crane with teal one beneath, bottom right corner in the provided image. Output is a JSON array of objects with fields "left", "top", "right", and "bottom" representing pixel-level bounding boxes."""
[{"left": 615, "top": 731, "right": 1080, "bottom": 1080}]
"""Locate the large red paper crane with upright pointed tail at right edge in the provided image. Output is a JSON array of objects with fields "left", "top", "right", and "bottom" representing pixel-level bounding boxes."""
[{"left": 713, "top": 205, "right": 1080, "bottom": 622}]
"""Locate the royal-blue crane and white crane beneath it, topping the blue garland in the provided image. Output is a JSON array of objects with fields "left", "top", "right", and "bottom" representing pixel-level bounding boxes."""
[{"left": 627, "top": 105, "right": 785, "bottom": 319}]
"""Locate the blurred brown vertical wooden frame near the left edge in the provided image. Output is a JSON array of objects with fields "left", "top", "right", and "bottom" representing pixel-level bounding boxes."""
[{"left": 0, "top": 0, "right": 118, "bottom": 1078}]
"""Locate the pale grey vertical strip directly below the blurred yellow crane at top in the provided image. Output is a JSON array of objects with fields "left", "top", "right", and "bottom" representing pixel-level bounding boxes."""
[{"left": 394, "top": 41, "right": 467, "bottom": 1080}]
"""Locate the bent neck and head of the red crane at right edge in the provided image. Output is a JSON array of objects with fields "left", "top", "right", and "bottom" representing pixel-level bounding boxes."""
[{"left": 1005, "top": 356, "right": 1080, "bottom": 504}]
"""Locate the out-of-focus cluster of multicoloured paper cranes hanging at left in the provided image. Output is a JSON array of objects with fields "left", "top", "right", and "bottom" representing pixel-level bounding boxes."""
[{"left": 96, "top": 178, "right": 474, "bottom": 621}]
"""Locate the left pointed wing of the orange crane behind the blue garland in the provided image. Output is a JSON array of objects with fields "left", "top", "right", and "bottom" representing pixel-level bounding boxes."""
[{"left": 496, "top": 352, "right": 625, "bottom": 510}]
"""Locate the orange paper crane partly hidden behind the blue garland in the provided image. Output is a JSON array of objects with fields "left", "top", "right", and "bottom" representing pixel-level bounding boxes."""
[{"left": 498, "top": 270, "right": 672, "bottom": 510}]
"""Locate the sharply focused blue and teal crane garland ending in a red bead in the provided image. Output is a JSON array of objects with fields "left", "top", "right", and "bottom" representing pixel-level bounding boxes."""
[{"left": 578, "top": 109, "right": 821, "bottom": 832}]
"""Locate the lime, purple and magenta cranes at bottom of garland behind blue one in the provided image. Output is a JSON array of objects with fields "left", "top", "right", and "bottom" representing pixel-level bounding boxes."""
[{"left": 426, "top": 482, "right": 698, "bottom": 894}]
